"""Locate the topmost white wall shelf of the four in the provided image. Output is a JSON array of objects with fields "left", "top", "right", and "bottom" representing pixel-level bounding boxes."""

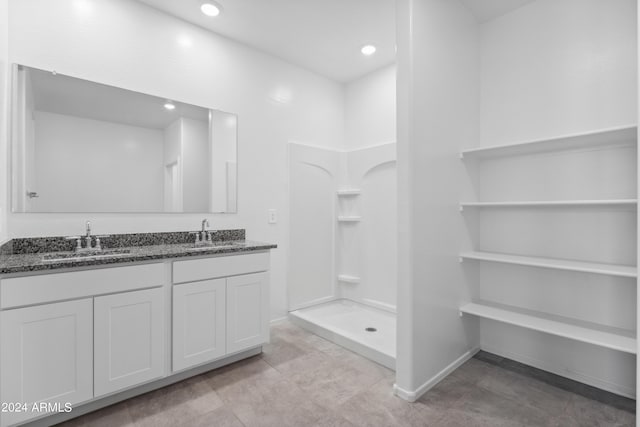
[{"left": 460, "top": 125, "right": 637, "bottom": 159}]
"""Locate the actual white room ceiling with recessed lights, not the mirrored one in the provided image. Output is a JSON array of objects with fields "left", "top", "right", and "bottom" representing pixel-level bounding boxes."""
[{"left": 139, "top": 0, "right": 534, "bottom": 82}]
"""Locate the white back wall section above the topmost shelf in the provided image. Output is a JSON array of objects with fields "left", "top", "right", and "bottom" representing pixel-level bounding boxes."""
[{"left": 480, "top": 0, "right": 637, "bottom": 145}]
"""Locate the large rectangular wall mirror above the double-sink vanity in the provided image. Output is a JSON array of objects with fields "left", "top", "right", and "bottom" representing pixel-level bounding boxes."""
[{"left": 12, "top": 65, "right": 237, "bottom": 213}]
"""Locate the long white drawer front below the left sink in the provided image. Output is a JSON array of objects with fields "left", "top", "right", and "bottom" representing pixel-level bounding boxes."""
[{"left": 0, "top": 263, "right": 164, "bottom": 309}]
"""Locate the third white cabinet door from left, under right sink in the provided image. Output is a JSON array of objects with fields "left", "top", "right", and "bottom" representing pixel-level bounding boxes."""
[{"left": 173, "top": 279, "right": 226, "bottom": 371}]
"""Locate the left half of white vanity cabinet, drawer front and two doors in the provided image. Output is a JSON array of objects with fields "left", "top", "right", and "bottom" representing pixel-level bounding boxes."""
[{"left": 0, "top": 263, "right": 166, "bottom": 427}]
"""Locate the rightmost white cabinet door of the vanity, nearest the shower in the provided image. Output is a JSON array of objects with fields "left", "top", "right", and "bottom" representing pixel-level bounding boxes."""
[{"left": 227, "top": 273, "right": 269, "bottom": 353}]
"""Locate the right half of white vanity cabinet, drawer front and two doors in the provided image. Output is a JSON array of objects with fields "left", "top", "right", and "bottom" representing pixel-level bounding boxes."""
[{"left": 172, "top": 252, "right": 269, "bottom": 371}]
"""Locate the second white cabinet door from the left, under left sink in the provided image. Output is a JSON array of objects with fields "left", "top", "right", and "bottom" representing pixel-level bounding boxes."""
[{"left": 94, "top": 288, "right": 165, "bottom": 397}]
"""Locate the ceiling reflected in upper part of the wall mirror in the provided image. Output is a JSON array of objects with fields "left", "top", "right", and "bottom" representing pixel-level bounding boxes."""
[{"left": 28, "top": 68, "right": 209, "bottom": 130}]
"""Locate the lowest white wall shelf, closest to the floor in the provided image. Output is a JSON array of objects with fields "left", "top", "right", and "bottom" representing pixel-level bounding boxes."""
[{"left": 460, "top": 303, "right": 637, "bottom": 354}]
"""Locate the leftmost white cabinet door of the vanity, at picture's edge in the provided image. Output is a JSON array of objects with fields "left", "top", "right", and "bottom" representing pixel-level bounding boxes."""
[{"left": 0, "top": 298, "right": 93, "bottom": 425}]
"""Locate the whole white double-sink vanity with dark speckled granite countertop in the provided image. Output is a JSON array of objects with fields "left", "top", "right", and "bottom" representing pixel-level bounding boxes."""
[{"left": 0, "top": 230, "right": 276, "bottom": 427}]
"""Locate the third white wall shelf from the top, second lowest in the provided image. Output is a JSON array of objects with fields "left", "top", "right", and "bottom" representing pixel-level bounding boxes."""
[{"left": 460, "top": 252, "right": 638, "bottom": 277}]
